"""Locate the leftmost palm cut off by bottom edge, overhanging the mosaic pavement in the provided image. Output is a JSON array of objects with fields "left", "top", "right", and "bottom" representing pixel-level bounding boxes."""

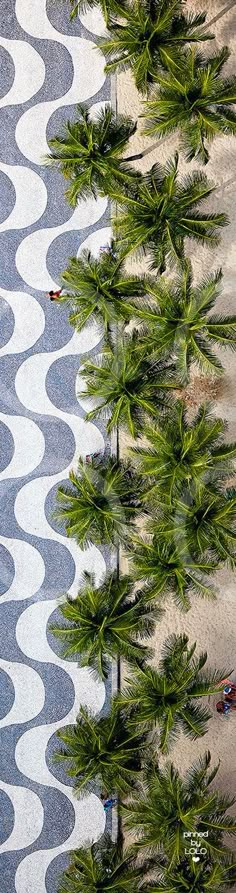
[{"left": 58, "top": 835, "right": 154, "bottom": 893}]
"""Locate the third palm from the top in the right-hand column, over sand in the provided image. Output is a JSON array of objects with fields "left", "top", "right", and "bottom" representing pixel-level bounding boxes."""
[{"left": 111, "top": 152, "right": 228, "bottom": 273}]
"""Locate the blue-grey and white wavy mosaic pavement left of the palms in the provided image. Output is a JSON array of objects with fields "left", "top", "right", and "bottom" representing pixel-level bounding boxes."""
[{"left": 0, "top": 0, "right": 110, "bottom": 893}]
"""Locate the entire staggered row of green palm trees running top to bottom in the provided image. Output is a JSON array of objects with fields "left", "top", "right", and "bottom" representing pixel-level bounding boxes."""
[{"left": 55, "top": 0, "right": 236, "bottom": 893}]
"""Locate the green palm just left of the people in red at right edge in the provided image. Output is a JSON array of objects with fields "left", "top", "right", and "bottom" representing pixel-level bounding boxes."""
[{"left": 118, "top": 634, "right": 229, "bottom": 753}]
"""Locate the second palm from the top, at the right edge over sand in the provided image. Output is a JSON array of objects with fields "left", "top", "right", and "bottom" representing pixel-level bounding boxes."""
[{"left": 144, "top": 47, "right": 236, "bottom": 164}]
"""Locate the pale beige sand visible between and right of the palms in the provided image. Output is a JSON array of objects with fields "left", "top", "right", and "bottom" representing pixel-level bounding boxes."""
[{"left": 118, "top": 0, "right": 236, "bottom": 811}]
